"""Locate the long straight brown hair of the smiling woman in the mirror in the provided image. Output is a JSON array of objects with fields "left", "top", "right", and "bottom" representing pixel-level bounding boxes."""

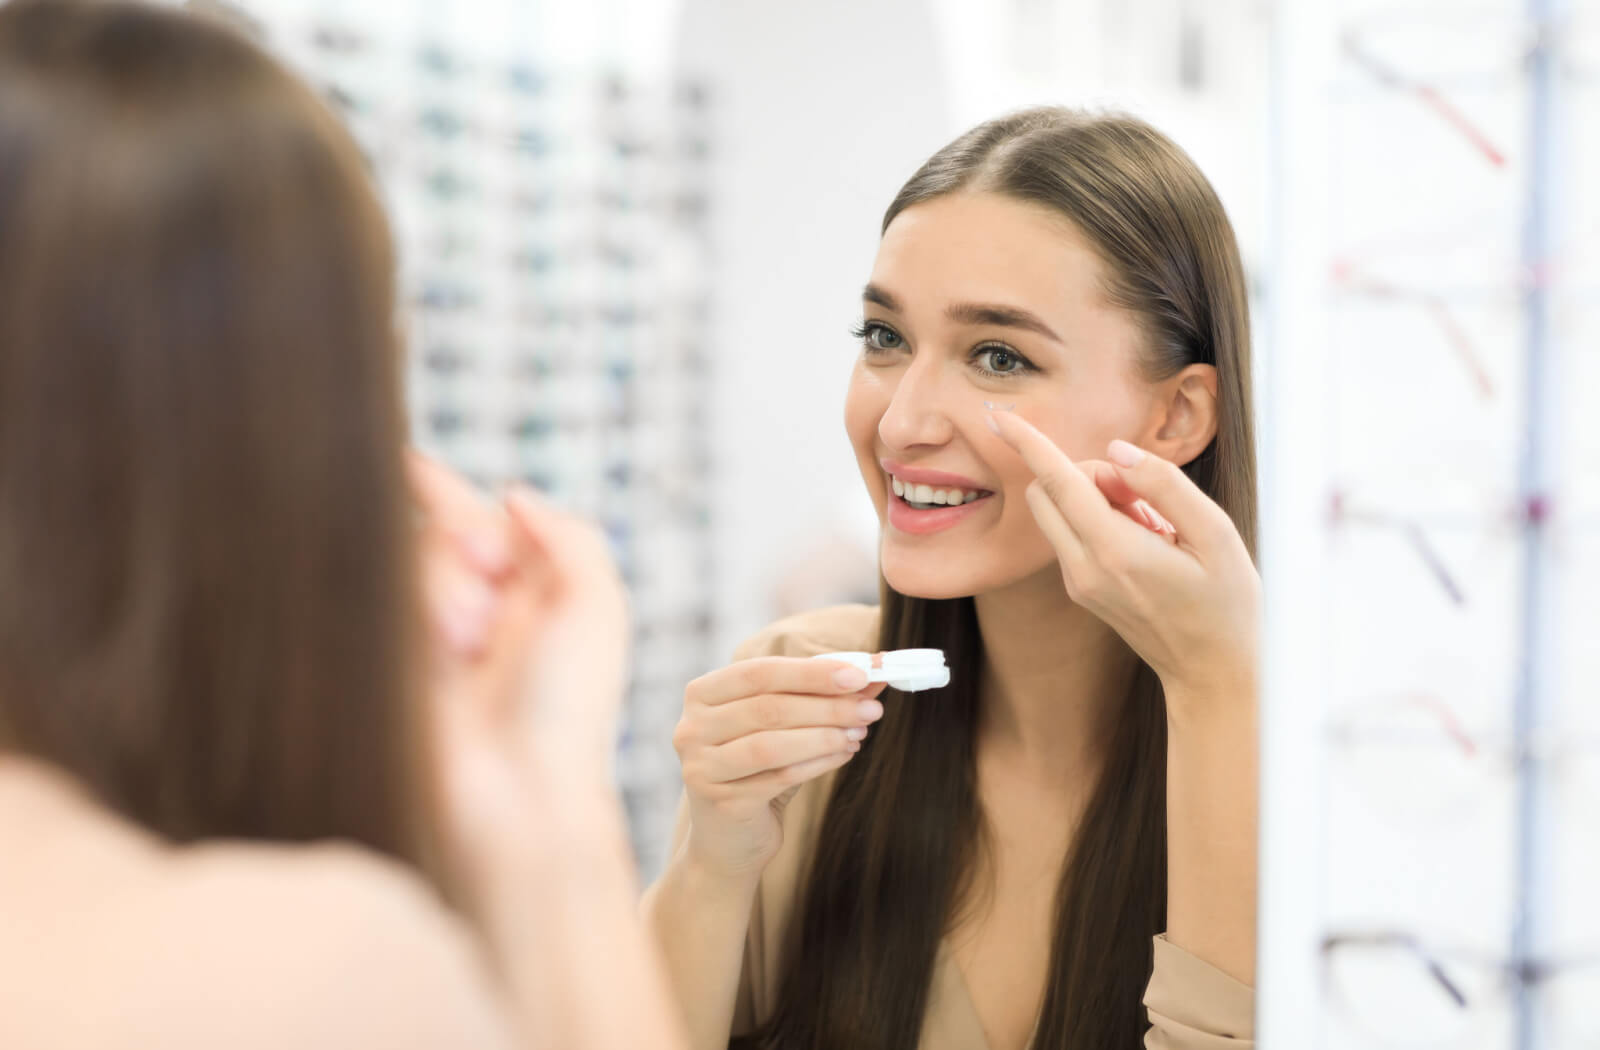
[{"left": 754, "top": 109, "right": 1256, "bottom": 1050}]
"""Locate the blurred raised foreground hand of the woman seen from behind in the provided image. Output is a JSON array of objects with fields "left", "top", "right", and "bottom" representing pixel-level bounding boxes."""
[{"left": 410, "top": 453, "right": 627, "bottom": 863}]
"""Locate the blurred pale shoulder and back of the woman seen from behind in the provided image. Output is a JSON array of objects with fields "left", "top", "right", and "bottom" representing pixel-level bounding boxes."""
[{"left": 0, "top": 761, "right": 507, "bottom": 1050}]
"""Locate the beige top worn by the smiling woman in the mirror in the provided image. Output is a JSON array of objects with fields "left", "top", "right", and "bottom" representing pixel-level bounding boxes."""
[{"left": 710, "top": 605, "right": 1256, "bottom": 1050}]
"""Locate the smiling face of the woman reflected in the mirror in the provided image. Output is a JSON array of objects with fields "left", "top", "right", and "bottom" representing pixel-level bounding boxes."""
[{"left": 845, "top": 194, "right": 1163, "bottom": 597}]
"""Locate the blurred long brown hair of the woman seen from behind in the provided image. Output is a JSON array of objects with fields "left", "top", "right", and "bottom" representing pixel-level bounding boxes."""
[{"left": 0, "top": 0, "right": 432, "bottom": 864}]
